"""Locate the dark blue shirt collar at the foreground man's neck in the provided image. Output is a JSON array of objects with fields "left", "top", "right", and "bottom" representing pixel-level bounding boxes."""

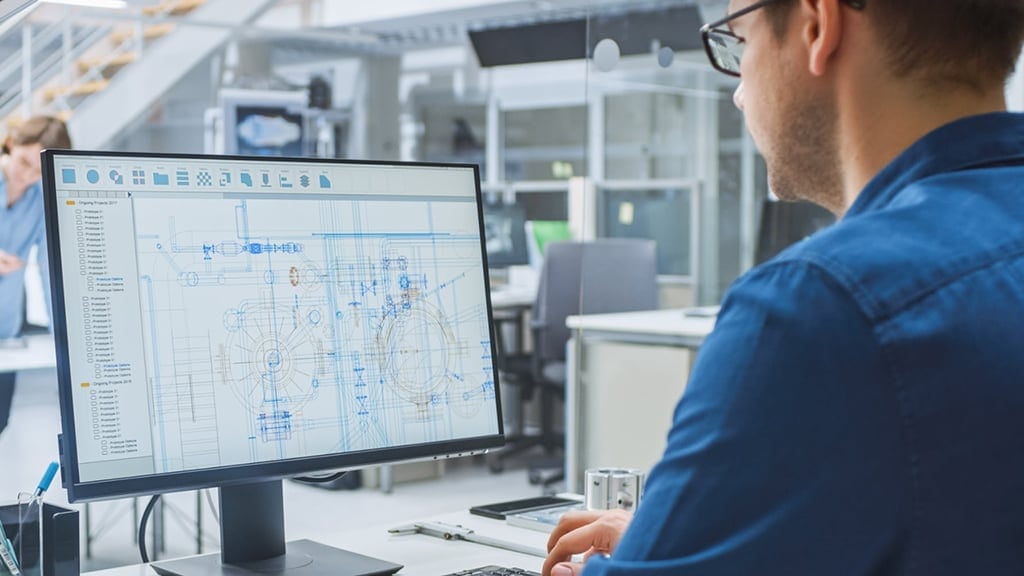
[{"left": 846, "top": 112, "right": 1024, "bottom": 217}]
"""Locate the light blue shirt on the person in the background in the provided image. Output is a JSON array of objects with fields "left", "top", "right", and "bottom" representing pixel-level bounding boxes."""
[{"left": 0, "top": 179, "right": 50, "bottom": 338}]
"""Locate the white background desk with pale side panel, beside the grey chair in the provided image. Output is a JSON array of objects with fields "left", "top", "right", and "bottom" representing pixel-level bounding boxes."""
[{"left": 565, "top": 310, "right": 715, "bottom": 492}]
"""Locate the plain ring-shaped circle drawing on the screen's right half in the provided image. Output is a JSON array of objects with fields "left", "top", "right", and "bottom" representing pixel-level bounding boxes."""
[{"left": 377, "top": 301, "right": 455, "bottom": 404}]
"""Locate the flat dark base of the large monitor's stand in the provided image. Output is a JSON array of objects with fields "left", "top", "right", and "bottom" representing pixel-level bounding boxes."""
[{"left": 151, "top": 540, "right": 402, "bottom": 576}]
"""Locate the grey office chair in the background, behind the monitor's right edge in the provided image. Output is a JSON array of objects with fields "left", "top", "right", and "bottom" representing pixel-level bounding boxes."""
[{"left": 489, "top": 239, "right": 657, "bottom": 484}]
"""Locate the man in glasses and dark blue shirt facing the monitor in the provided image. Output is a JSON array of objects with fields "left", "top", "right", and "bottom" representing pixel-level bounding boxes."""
[{"left": 544, "top": 0, "right": 1024, "bottom": 576}]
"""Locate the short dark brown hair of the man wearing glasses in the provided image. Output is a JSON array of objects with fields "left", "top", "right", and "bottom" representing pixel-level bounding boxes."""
[{"left": 766, "top": 0, "right": 1024, "bottom": 90}]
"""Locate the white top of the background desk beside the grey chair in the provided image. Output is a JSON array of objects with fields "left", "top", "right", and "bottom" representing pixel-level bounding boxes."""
[{"left": 565, "top": 308, "right": 715, "bottom": 347}]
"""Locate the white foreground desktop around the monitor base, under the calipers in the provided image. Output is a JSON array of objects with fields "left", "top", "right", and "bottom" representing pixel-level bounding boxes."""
[{"left": 86, "top": 509, "right": 548, "bottom": 576}]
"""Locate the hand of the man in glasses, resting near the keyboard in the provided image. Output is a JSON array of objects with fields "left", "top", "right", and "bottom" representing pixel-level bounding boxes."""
[{"left": 542, "top": 510, "right": 633, "bottom": 576}]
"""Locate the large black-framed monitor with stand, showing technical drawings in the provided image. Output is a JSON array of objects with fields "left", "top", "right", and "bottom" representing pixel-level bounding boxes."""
[{"left": 43, "top": 151, "right": 504, "bottom": 576}]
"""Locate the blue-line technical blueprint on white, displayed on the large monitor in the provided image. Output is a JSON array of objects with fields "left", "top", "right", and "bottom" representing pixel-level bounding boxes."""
[{"left": 134, "top": 196, "right": 498, "bottom": 472}]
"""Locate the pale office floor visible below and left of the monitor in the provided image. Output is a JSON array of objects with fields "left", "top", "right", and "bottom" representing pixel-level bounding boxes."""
[{"left": 0, "top": 371, "right": 542, "bottom": 571}]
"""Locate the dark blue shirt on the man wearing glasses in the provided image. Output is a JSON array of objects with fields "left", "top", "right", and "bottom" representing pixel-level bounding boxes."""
[{"left": 585, "top": 114, "right": 1024, "bottom": 576}]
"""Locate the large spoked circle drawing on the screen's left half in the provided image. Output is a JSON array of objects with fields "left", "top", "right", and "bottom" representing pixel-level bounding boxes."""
[{"left": 220, "top": 302, "right": 326, "bottom": 416}]
